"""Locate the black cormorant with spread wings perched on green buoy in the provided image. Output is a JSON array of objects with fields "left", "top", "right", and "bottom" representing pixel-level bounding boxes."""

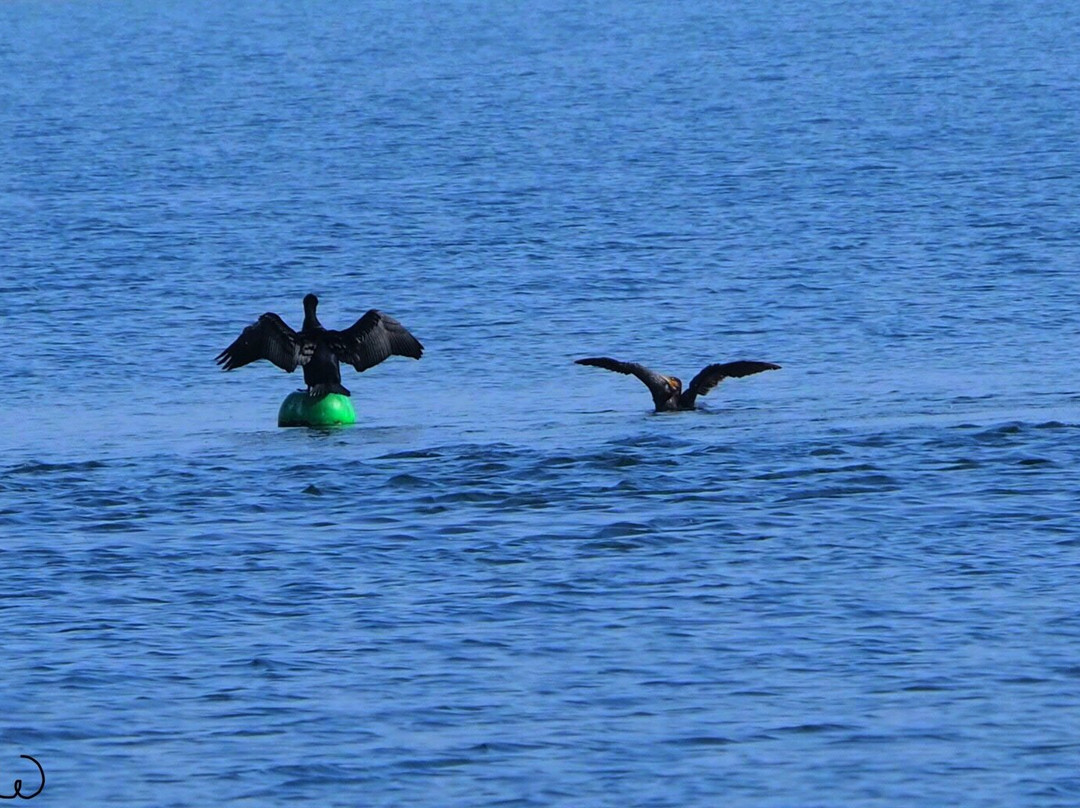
[{"left": 215, "top": 295, "right": 423, "bottom": 396}]
